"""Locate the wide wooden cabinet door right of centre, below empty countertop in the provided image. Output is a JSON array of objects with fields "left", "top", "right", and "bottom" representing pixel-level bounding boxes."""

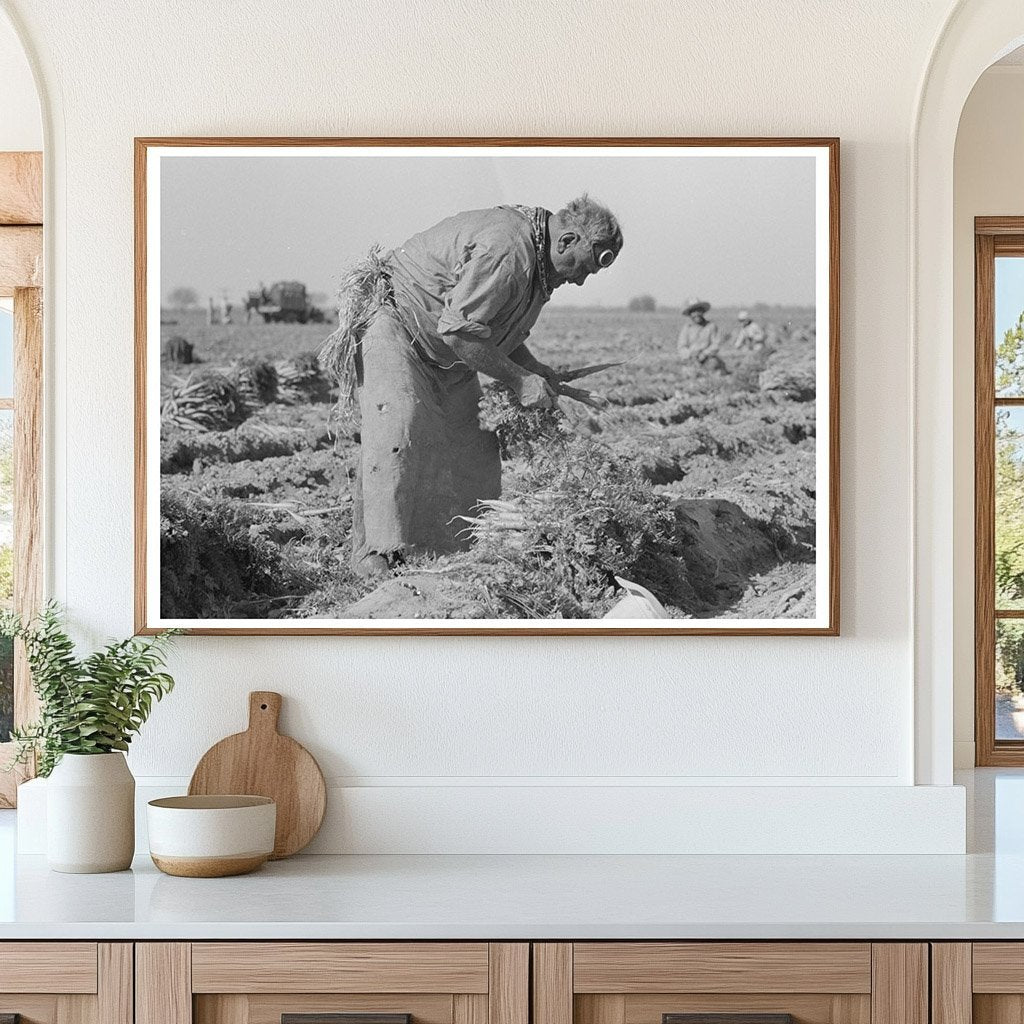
[{"left": 534, "top": 942, "right": 928, "bottom": 1024}]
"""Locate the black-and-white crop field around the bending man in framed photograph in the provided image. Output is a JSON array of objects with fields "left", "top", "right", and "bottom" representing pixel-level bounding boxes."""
[{"left": 161, "top": 308, "right": 816, "bottom": 618}]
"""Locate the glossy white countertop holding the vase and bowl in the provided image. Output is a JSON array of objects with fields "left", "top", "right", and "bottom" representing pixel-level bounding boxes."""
[{"left": 0, "top": 772, "right": 1024, "bottom": 939}]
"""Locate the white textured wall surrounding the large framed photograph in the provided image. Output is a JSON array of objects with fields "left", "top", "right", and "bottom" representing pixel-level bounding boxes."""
[{"left": 5, "top": 0, "right": 974, "bottom": 843}]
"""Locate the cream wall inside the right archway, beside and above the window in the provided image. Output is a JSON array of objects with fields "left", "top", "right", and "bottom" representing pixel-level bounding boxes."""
[{"left": 953, "top": 63, "right": 1024, "bottom": 768}]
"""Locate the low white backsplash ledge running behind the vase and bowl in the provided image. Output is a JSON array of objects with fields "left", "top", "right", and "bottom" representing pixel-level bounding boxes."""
[{"left": 17, "top": 778, "right": 967, "bottom": 855}]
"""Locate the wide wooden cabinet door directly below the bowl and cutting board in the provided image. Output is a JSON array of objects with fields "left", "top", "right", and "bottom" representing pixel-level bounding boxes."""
[{"left": 136, "top": 942, "right": 529, "bottom": 1024}]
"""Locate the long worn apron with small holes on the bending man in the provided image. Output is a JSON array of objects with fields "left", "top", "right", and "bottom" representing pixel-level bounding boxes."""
[{"left": 352, "top": 308, "right": 502, "bottom": 564}]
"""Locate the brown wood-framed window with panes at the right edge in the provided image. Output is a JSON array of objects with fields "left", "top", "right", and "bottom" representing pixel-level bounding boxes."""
[{"left": 975, "top": 217, "right": 1024, "bottom": 765}]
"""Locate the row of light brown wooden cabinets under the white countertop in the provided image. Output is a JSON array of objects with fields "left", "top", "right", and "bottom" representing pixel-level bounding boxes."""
[{"left": 0, "top": 941, "right": 983, "bottom": 1024}]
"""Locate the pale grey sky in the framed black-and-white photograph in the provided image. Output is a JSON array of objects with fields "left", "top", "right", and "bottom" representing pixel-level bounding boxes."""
[{"left": 161, "top": 148, "right": 814, "bottom": 306}]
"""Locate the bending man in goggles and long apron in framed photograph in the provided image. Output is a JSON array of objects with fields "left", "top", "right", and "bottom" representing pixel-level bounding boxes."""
[{"left": 336, "top": 196, "right": 623, "bottom": 574}]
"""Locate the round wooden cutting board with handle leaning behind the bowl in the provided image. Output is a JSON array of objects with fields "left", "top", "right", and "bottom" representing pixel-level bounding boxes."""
[{"left": 188, "top": 690, "right": 327, "bottom": 860}]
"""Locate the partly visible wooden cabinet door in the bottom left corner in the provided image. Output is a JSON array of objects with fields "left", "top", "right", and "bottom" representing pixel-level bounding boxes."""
[{"left": 0, "top": 942, "right": 132, "bottom": 1024}]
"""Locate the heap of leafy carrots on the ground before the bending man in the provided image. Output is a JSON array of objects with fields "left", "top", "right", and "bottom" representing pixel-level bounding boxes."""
[{"left": 450, "top": 407, "right": 688, "bottom": 618}]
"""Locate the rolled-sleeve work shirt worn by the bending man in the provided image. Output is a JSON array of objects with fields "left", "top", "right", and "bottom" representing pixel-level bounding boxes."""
[{"left": 389, "top": 206, "right": 550, "bottom": 367}]
